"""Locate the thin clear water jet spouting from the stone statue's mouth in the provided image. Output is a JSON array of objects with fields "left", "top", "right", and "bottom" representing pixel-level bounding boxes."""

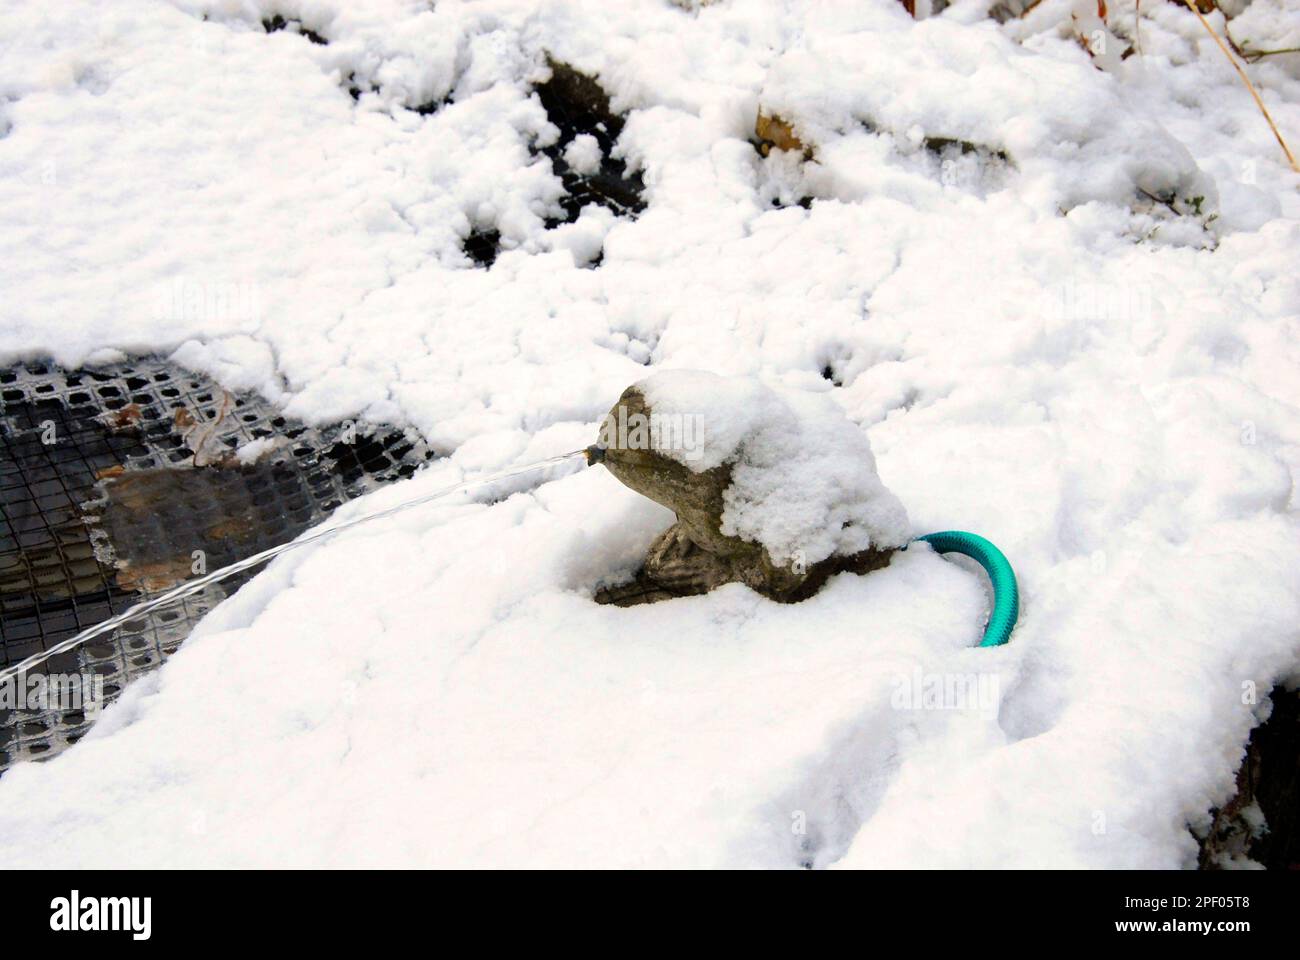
[{"left": 0, "top": 447, "right": 598, "bottom": 683}]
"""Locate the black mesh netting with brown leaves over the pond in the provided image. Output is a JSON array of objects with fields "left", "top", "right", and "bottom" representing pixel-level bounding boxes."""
[{"left": 0, "top": 359, "right": 432, "bottom": 771}]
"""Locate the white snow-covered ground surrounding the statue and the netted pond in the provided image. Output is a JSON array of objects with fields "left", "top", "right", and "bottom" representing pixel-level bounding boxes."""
[{"left": 0, "top": 0, "right": 1300, "bottom": 866}]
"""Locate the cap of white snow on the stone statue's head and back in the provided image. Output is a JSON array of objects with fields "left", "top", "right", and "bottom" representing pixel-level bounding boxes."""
[{"left": 636, "top": 369, "right": 911, "bottom": 563}]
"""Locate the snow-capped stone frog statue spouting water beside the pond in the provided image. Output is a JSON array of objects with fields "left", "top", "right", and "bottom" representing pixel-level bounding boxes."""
[{"left": 592, "top": 371, "right": 910, "bottom": 606}]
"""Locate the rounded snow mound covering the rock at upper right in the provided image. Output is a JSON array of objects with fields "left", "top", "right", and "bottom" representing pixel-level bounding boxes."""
[{"left": 761, "top": 4, "right": 1217, "bottom": 209}]
